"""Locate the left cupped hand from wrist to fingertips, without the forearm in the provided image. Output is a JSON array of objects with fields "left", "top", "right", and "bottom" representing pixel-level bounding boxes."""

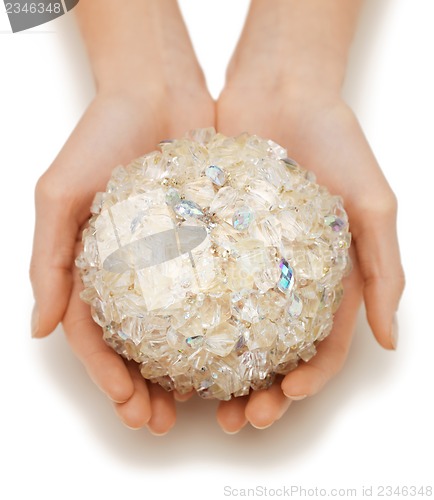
[{"left": 30, "top": 85, "right": 214, "bottom": 434}]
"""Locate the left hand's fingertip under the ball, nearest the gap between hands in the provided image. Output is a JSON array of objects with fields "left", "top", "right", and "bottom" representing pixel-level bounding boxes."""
[{"left": 144, "top": 382, "right": 176, "bottom": 436}]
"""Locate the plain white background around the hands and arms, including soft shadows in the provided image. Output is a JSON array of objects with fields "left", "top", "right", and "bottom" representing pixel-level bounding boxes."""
[{"left": 0, "top": 0, "right": 434, "bottom": 500}]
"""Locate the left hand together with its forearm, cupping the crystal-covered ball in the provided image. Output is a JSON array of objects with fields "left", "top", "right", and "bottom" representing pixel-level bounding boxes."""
[{"left": 30, "top": 0, "right": 214, "bottom": 434}]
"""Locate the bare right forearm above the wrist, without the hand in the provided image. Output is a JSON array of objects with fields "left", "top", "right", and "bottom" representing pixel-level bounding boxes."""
[{"left": 229, "top": 0, "right": 363, "bottom": 91}]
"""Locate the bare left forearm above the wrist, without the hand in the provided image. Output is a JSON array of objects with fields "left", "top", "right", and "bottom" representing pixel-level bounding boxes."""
[{"left": 76, "top": 0, "right": 200, "bottom": 91}]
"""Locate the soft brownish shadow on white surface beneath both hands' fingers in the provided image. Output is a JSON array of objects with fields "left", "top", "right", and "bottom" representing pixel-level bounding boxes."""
[{"left": 35, "top": 304, "right": 396, "bottom": 471}]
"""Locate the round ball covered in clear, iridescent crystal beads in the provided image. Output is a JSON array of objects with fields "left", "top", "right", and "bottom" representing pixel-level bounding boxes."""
[{"left": 76, "top": 129, "right": 351, "bottom": 400}]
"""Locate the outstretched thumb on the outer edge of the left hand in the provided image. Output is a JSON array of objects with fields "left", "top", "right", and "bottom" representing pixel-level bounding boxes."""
[{"left": 30, "top": 172, "right": 78, "bottom": 337}]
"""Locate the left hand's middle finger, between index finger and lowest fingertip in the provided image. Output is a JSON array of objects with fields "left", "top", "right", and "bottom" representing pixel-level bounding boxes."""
[{"left": 114, "top": 361, "right": 151, "bottom": 429}]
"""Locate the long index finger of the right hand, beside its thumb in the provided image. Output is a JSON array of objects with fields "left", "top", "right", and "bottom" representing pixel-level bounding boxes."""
[{"left": 282, "top": 259, "right": 362, "bottom": 400}]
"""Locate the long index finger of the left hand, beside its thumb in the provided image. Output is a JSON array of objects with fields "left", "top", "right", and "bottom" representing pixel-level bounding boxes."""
[{"left": 63, "top": 271, "right": 134, "bottom": 402}]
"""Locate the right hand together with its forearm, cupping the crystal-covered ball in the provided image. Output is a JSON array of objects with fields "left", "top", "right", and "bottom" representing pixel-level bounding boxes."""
[{"left": 217, "top": 0, "right": 404, "bottom": 432}]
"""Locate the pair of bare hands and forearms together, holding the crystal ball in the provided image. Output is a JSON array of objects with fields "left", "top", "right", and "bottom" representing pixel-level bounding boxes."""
[{"left": 30, "top": 0, "right": 404, "bottom": 434}]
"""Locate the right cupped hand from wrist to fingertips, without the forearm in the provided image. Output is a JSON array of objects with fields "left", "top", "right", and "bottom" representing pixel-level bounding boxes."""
[{"left": 217, "top": 81, "right": 404, "bottom": 432}]
